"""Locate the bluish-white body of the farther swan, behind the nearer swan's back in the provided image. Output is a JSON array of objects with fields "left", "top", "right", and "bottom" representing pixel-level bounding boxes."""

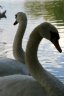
[{"left": 0, "top": 58, "right": 29, "bottom": 76}]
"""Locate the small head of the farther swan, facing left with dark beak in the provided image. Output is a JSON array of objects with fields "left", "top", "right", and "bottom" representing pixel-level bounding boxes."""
[{"left": 14, "top": 12, "right": 27, "bottom": 25}]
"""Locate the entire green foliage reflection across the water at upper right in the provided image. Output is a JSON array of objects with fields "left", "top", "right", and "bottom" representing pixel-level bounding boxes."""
[{"left": 25, "top": 0, "right": 64, "bottom": 26}]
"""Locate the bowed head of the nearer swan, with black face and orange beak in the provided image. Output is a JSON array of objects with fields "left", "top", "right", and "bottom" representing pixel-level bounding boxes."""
[{"left": 40, "top": 22, "right": 62, "bottom": 52}]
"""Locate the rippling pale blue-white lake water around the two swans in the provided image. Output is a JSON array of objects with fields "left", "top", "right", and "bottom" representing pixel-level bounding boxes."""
[{"left": 0, "top": 0, "right": 64, "bottom": 82}]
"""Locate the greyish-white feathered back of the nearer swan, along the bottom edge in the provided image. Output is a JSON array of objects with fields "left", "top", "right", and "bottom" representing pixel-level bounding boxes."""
[{"left": 0, "top": 75, "right": 47, "bottom": 96}]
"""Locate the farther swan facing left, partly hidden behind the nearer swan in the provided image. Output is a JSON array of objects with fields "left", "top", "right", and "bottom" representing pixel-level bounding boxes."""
[{"left": 0, "top": 14, "right": 29, "bottom": 76}]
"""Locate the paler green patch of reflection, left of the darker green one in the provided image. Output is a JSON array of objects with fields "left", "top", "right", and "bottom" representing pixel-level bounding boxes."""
[{"left": 25, "top": 0, "right": 44, "bottom": 18}]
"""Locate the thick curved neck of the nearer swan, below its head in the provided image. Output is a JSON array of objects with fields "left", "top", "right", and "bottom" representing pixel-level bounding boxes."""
[{"left": 25, "top": 30, "right": 63, "bottom": 96}]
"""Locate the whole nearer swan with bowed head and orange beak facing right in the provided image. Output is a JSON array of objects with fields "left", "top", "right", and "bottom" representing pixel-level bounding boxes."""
[{"left": 0, "top": 13, "right": 64, "bottom": 96}]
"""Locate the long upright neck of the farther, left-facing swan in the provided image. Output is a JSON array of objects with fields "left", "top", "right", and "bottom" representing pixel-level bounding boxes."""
[{"left": 13, "top": 21, "right": 27, "bottom": 64}]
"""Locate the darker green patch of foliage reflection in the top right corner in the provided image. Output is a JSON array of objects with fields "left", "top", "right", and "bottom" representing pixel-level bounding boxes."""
[{"left": 44, "top": 0, "right": 64, "bottom": 23}]
